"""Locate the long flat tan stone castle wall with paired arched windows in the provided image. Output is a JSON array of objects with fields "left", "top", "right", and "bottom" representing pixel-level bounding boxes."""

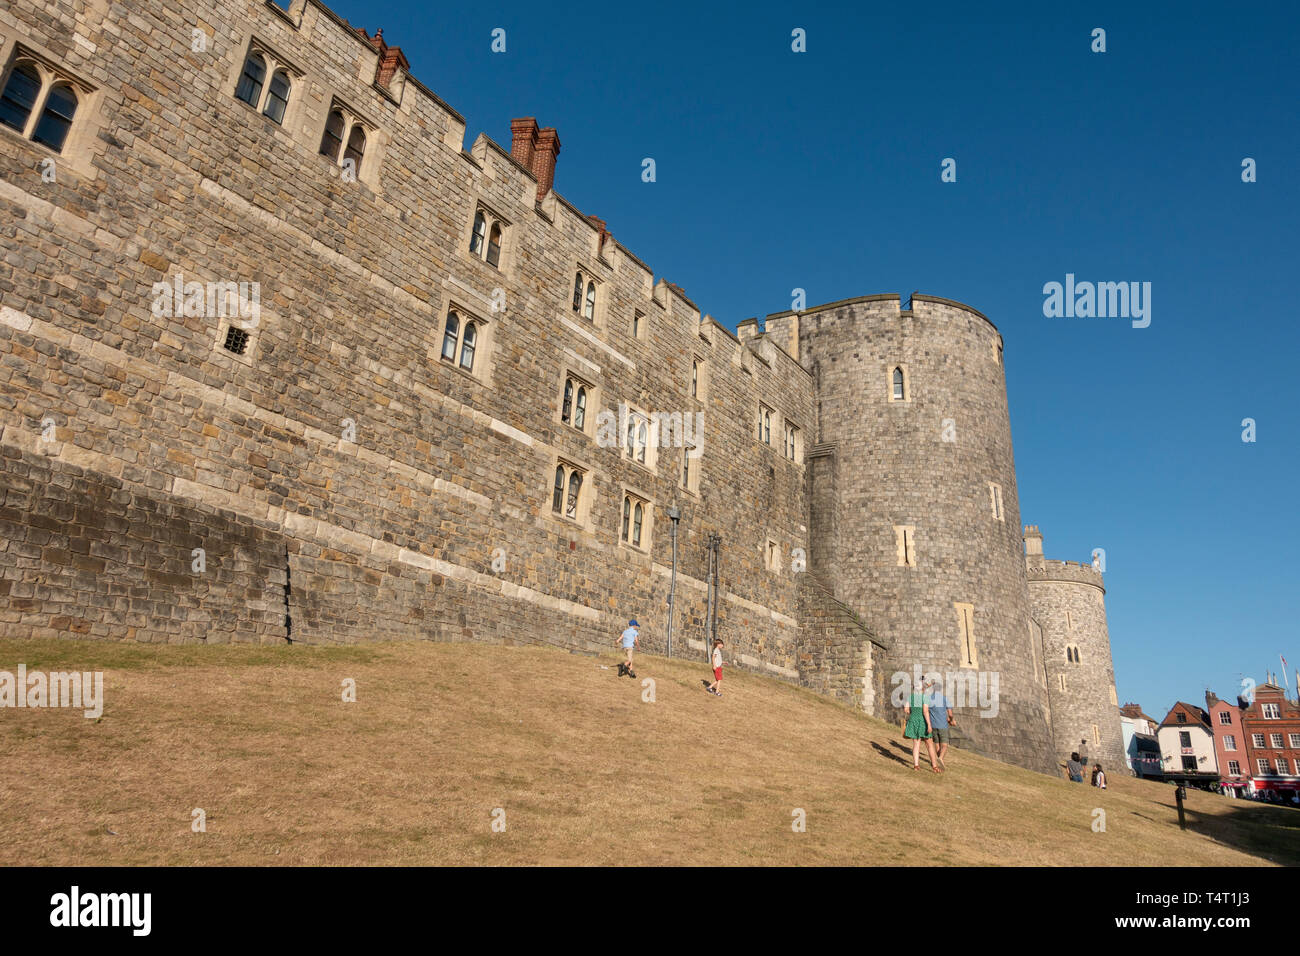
[{"left": 0, "top": 0, "right": 811, "bottom": 679}]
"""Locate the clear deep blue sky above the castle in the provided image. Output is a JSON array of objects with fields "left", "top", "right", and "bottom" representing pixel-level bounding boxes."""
[{"left": 333, "top": 0, "right": 1300, "bottom": 719}]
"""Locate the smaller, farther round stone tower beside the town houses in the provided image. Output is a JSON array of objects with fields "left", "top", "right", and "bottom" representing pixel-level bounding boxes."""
[{"left": 1024, "top": 524, "right": 1125, "bottom": 774}]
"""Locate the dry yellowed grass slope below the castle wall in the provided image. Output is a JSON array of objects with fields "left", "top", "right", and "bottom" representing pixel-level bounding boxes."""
[{"left": 0, "top": 641, "right": 1300, "bottom": 866}]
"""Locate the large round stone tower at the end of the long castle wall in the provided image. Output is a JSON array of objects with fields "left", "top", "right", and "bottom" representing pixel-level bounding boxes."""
[{"left": 796, "top": 294, "right": 1056, "bottom": 773}]
